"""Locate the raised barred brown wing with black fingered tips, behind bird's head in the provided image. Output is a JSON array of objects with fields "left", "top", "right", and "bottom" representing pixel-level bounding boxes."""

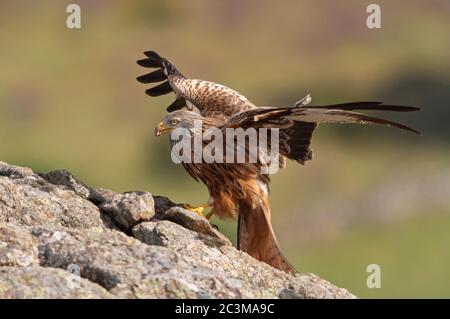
[{"left": 137, "top": 51, "right": 255, "bottom": 117}]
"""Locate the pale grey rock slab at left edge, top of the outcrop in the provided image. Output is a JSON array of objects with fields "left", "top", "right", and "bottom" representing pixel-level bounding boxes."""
[{"left": 0, "top": 162, "right": 105, "bottom": 228}]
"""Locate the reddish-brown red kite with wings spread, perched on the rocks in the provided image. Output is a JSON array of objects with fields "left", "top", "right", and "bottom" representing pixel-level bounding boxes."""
[{"left": 137, "top": 51, "right": 418, "bottom": 272}]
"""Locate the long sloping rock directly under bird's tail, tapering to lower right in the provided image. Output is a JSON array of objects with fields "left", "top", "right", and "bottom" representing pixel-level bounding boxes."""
[{"left": 133, "top": 221, "right": 351, "bottom": 298}]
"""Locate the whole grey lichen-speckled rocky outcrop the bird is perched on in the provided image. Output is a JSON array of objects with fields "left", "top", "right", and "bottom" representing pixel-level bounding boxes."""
[{"left": 0, "top": 162, "right": 353, "bottom": 298}]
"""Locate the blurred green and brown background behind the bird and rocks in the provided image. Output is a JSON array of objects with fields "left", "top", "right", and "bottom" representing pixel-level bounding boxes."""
[{"left": 0, "top": 0, "right": 450, "bottom": 298}]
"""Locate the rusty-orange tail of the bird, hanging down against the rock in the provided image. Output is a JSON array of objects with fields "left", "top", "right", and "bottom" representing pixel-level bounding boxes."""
[{"left": 238, "top": 200, "right": 297, "bottom": 273}]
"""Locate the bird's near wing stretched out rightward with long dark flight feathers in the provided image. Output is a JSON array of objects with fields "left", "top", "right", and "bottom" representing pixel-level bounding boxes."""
[{"left": 226, "top": 102, "right": 420, "bottom": 164}]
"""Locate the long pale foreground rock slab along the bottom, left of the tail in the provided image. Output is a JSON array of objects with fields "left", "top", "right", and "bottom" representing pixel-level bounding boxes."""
[{"left": 33, "top": 225, "right": 270, "bottom": 298}]
